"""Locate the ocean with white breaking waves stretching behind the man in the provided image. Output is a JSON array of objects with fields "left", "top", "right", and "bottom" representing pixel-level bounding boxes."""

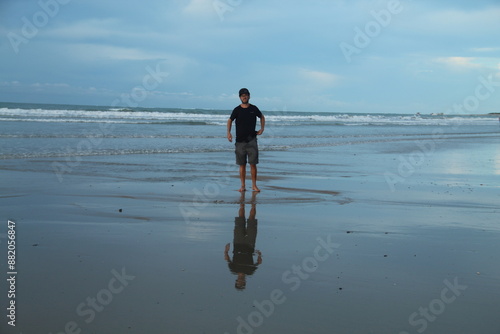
[{"left": 0, "top": 103, "right": 499, "bottom": 159}]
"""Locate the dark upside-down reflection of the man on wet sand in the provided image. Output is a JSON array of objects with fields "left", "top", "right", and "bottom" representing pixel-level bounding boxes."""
[{"left": 224, "top": 192, "right": 262, "bottom": 290}]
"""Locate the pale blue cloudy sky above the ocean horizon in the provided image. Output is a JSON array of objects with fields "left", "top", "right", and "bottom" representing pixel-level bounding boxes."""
[{"left": 0, "top": 0, "right": 500, "bottom": 114}]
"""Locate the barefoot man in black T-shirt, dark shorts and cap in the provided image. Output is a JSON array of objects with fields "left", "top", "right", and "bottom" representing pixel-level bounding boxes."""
[{"left": 227, "top": 88, "right": 266, "bottom": 192}]
